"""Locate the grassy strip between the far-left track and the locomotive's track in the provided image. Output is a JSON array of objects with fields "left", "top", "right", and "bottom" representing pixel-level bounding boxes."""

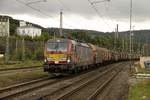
[{"left": 0, "top": 70, "right": 48, "bottom": 88}]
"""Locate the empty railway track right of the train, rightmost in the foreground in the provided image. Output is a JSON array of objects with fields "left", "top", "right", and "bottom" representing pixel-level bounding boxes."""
[{"left": 51, "top": 63, "right": 123, "bottom": 100}]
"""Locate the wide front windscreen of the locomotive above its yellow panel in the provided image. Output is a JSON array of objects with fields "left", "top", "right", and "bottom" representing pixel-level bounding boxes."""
[{"left": 47, "top": 42, "right": 67, "bottom": 51}]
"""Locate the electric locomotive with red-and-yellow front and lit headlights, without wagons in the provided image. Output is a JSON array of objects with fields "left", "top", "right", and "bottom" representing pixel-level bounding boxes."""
[{"left": 44, "top": 39, "right": 94, "bottom": 73}]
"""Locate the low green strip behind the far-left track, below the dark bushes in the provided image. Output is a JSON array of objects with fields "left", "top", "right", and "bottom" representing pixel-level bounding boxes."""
[{"left": 0, "top": 60, "right": 43, "bottom": 69}]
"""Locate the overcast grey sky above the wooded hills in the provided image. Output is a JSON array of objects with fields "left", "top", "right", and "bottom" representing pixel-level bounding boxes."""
[{"left": 0, "top": 0, "right": 150, "bottom": 32}]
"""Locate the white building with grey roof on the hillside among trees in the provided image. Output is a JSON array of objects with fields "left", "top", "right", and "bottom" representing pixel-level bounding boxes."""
[{"left": 17, "top": 21, "right": 42, "bottom": 38}]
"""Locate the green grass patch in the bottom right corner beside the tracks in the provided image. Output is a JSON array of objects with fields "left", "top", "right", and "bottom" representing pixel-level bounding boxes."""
[{"left": 129, "top": 79, "right": 150, "bottom": 100}]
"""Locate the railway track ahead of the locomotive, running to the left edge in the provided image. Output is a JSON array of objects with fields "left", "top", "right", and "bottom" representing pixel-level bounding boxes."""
[{"left": 0, "top": 77, "right": 60, "bottom": 100}]
